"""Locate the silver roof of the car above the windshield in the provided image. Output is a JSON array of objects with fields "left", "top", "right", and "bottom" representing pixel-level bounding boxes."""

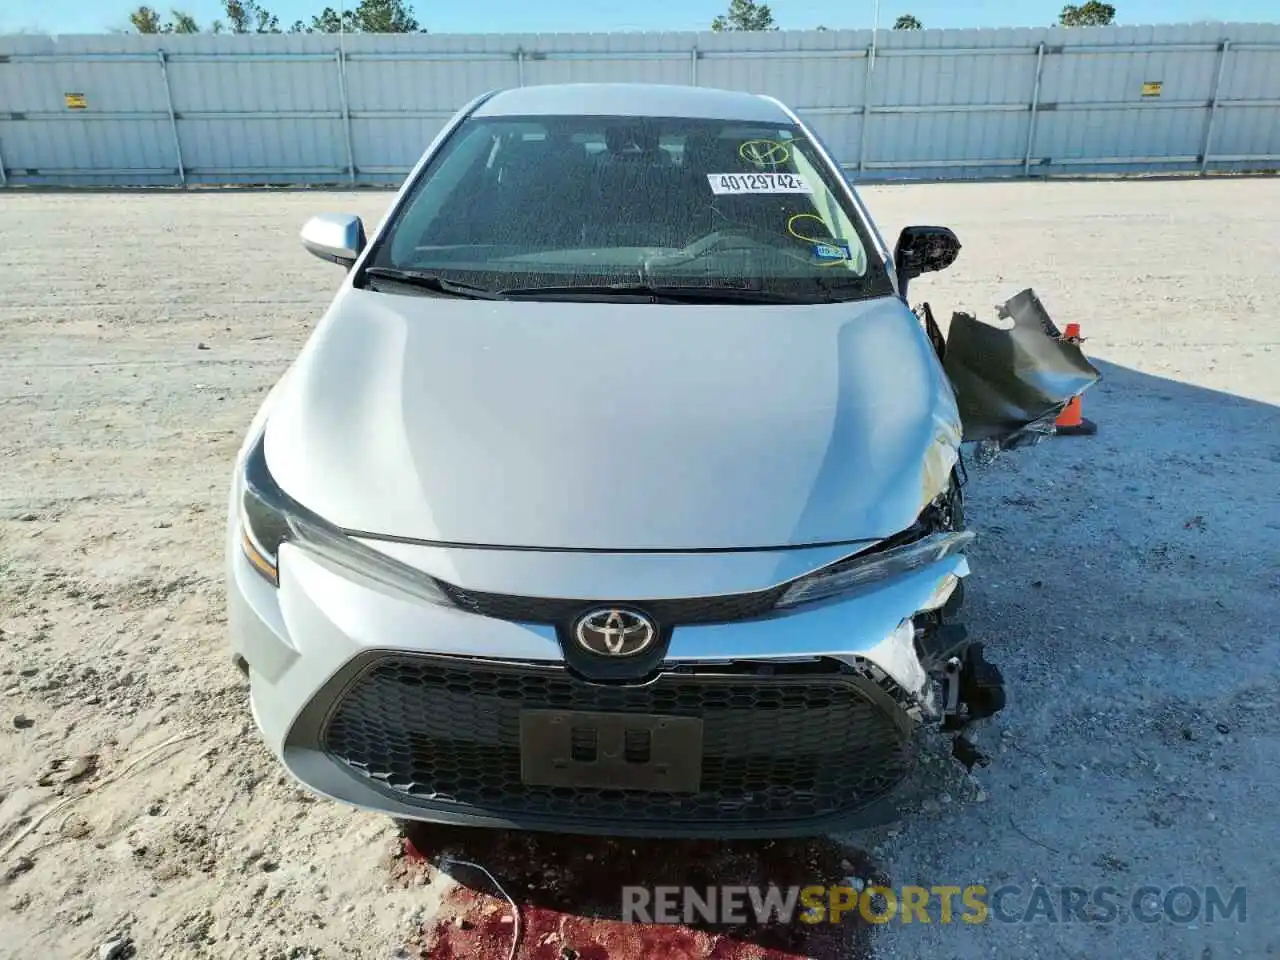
[{"left": 474, "top": 83, "right": 794, "bottom": 124}]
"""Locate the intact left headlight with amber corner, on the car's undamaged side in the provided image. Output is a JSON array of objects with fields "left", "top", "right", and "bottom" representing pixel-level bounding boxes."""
[{"left": 239, "top": 431, "right": 451, "bottom": 604}]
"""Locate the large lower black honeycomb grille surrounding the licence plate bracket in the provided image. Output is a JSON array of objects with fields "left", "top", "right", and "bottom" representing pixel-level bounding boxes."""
[{"left": 320, "top": 657, "right": 908, "bottom": 826}]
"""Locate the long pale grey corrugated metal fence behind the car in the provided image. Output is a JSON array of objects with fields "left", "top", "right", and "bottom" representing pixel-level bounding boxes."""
[{"left": 0, "top": 23, "right": 1280, "bottom": 186}]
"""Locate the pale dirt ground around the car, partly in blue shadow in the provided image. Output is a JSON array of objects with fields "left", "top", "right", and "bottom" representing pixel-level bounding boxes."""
[{"left": 0, "top": 179, "right": 1280, "bottom": 960}]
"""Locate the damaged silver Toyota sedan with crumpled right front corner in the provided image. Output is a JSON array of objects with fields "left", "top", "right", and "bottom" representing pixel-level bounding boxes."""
[{"left": 227, "top": 84, "right": 1096, "bottom": 836}]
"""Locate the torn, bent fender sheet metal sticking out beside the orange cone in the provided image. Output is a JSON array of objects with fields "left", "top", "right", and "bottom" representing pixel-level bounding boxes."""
[{"left": 942, "top": 288, "right": 1102, "bottom": 448}]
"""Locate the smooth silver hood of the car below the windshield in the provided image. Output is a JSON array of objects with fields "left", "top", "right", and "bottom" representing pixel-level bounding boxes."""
[{"left": 265, "top": 287, "right": 960, "bottom": 552}]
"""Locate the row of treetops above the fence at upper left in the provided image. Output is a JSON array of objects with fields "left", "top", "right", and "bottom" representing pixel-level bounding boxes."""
[{"left": 129, "top": 0, "right": 426, "bottom": 33}]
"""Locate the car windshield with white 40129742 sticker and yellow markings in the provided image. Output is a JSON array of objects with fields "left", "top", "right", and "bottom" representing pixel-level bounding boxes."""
[{"left": 366, "top": 116, "right": 893, "bottom": 302}]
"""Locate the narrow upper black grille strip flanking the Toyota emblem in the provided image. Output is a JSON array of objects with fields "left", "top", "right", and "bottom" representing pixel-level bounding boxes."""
[{"left": 440, "top": 582, "right": 788, "bottom": 627}]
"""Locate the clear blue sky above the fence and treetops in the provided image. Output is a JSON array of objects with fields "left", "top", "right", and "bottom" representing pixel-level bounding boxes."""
[{"left": 0, "top": 0, "right": 1280, "bottom": 33}]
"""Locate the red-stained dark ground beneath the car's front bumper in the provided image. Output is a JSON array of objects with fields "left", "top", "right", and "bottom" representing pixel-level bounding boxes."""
[{"left": 393, "top": 823, "right": 884, "bottom": 960}]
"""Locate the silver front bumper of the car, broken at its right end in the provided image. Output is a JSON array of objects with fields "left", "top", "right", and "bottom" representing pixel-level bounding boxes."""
[{"left": 228, "top": 538, "right": 968, "bottom": 837}]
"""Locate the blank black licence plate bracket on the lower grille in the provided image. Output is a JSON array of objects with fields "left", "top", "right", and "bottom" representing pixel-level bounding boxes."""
[{"left": 520, "top": 710, "right": 703, "bottom": 794}]
